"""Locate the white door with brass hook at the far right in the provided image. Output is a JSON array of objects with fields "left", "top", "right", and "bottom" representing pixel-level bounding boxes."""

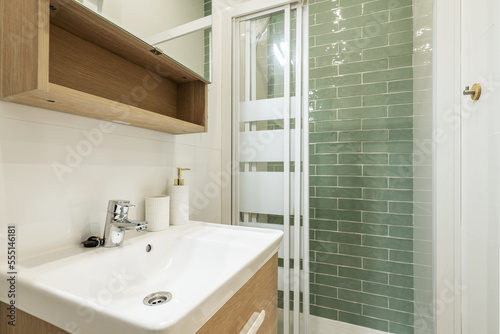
[{"left": 456, "top": 0, "right": 500, "bottom": 334}]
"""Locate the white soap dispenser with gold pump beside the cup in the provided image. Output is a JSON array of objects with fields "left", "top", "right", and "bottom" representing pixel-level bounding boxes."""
[{"left": 168, "top": 167, "right": 191, "bottom": 225}]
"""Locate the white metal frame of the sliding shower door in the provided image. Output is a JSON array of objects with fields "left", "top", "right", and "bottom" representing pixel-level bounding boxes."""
[{"left": 231, "top": 2, "right": 309, "bottom": 334}]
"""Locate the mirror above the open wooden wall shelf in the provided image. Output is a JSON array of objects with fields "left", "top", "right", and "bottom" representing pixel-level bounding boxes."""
[{"left": 78, "top": 0, "right": 212, "bottom": 80}]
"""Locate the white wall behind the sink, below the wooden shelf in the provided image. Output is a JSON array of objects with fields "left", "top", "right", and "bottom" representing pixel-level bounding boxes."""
[{"left": 0, "top": 1, "right": 221, "bottom": 262}]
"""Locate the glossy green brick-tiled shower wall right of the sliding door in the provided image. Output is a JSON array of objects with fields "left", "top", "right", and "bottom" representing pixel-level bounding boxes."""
[{"left": 309, "top": 0, "right": 414, "bottom": 334}]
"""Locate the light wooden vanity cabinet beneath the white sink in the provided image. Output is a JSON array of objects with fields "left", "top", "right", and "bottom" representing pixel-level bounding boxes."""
[{"left": 0, "top": 254, "right": 278, "bottom": 334}]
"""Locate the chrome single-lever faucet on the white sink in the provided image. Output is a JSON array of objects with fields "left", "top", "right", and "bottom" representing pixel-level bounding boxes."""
[{"left": 102, "top": 200, "right": 148, "bottom": 248}]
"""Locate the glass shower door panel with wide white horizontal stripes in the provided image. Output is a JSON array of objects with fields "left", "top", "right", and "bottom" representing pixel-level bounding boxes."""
[{"left": 233, "top": 6, "right": 303, "bottom": 333}]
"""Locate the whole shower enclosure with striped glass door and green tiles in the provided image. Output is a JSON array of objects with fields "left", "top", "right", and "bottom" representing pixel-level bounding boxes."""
[{"left": 232, "top": 0, "right": 434, "bottom": 333}]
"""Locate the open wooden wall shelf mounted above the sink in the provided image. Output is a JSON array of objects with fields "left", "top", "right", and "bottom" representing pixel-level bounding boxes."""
[{"left": 0, "top": 0, "right": 209, "bottom": 134}]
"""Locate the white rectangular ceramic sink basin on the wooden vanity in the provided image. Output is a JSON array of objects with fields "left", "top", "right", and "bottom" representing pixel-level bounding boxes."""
[{"left": 0, "top": 222, "right": 283, "bottom": 334}]
